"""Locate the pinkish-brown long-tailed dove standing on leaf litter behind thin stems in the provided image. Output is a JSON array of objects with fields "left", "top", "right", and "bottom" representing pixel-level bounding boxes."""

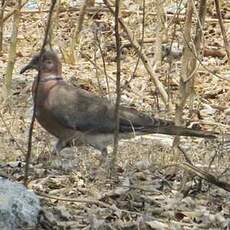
[{"left": 20, "top": 48, "right": 216, "bottom": 158}]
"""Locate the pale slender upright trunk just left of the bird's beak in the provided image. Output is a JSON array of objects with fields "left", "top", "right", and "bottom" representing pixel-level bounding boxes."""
[{"left": 5, "top": 0, "right": 21, "bottom": 90}]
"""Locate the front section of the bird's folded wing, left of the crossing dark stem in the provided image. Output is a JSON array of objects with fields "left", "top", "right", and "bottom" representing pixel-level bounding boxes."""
[{"left": 46, "top": 83, "right": 117, "bottom": 133}]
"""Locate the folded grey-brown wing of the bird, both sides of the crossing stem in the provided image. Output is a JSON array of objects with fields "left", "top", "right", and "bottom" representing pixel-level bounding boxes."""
[{"left": 46, "top": 83, "right": 160, "bottom": 133}]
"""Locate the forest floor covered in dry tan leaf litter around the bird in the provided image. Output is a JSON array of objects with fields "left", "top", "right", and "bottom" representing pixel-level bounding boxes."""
[{"left": 0, "top": 1, "right": 230, "bottom": 229}]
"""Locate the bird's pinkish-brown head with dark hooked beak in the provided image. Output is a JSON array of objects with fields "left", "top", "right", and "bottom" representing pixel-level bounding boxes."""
[{"left": 20, "top": 49, "right": 61, "bottom": 75}]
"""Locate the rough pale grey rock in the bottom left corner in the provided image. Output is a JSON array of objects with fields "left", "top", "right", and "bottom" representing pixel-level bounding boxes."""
[{"left": 0, "top": 177, "right": 41, "bottom": 230}]
